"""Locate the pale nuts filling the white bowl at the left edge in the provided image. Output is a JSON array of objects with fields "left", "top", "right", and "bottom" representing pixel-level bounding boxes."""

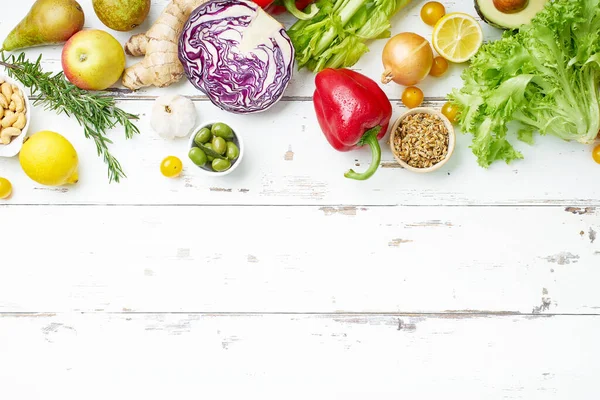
[{"left": 0, "top": 78, "right": 27, "bottom": 144}]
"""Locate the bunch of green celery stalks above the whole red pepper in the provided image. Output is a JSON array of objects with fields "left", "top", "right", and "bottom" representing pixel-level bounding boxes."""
[{"left": 287, "top": 0, "right": 410, "bottom": 72}]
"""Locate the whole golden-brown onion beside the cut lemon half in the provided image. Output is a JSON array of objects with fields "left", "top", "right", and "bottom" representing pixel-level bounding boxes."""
[{"left": 381, "top": 32, "right": 433, "bottom": 86}]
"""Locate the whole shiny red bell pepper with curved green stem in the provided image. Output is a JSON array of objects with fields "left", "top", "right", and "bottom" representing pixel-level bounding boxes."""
[{"left": 313, "top": 68, "right": 392, "bottom": 180}]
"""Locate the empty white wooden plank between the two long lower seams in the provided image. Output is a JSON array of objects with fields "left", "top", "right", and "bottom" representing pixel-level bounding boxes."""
[{"left": 0, "top": 206, "right": 600, "bottom": 314}]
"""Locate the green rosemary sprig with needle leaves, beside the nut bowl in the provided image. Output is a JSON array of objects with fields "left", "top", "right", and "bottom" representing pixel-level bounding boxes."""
[{"left": 0, "top": 52, "right": 140, "bottom": 182}]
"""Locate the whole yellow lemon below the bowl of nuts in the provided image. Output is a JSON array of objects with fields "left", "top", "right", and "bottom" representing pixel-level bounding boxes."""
[{"left": 19, "top": 131, "right": 79, "bottom": 186}]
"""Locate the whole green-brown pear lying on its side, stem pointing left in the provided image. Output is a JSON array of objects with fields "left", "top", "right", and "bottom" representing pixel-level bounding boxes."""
[{"left": 2, "top": 0, "right": 85, "bottom": 51}]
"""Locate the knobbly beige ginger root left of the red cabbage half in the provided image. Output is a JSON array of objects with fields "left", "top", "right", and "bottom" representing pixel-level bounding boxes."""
[{"left": 123, "top": 0, "right": 208, "bottom": 90}]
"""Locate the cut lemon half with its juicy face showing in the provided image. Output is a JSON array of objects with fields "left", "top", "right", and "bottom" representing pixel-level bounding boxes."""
[{"left": 432, "top": 12, "right": 483, "bottom": 63}]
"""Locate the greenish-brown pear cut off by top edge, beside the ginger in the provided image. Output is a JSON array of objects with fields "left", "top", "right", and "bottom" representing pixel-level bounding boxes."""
[{"left": 92, "top": 0, "right": 150, "bottom": 32}]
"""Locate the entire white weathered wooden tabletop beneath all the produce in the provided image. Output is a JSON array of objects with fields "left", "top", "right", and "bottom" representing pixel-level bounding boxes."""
[{"left": 0, "top": 0, "right": 600, "bottom": 400}]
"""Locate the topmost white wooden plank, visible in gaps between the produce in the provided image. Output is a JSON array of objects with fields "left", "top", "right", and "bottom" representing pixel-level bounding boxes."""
[{"left": 0, "top": 0, "right": 501, "bottom": 100}]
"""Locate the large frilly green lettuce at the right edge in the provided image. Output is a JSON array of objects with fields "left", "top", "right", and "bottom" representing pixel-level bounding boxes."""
[{"left": 450, "top": 0, "right": 600, "bottom": 167}]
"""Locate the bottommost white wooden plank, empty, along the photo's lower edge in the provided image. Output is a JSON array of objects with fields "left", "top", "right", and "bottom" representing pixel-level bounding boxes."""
[{"left": 0, "top": 313, "right": 600, "bottom": 400}]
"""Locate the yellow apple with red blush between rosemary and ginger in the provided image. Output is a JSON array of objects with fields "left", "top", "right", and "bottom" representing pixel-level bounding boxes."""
[{"left": 62, "top": 29, "right": 125, "bottom": 90}]
